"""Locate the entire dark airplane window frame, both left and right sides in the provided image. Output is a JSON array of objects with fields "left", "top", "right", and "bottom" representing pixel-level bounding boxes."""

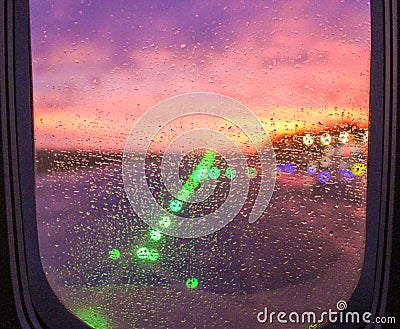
[{"left": 0, "top": 0, "right": 398, "bottom": 329}]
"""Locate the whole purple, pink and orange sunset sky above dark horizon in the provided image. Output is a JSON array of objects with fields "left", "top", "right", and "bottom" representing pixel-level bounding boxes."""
[{"left": 31, "top": 0, "right": 371, "bottom": 151}]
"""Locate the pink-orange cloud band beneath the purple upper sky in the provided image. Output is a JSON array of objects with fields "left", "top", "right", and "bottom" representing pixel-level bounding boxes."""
[{"left": 33, "top": 2, "right": 370, "bottom": 149}]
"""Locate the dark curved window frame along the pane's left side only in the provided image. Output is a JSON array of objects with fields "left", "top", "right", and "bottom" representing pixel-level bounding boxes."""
[{"left": 1, "top": 0, "right": 89, "bottom": 329}]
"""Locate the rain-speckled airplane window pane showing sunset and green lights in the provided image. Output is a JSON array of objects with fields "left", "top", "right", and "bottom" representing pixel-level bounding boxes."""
[{"left": 30, "top": 0, "right": 371, "bottom": 329}]
